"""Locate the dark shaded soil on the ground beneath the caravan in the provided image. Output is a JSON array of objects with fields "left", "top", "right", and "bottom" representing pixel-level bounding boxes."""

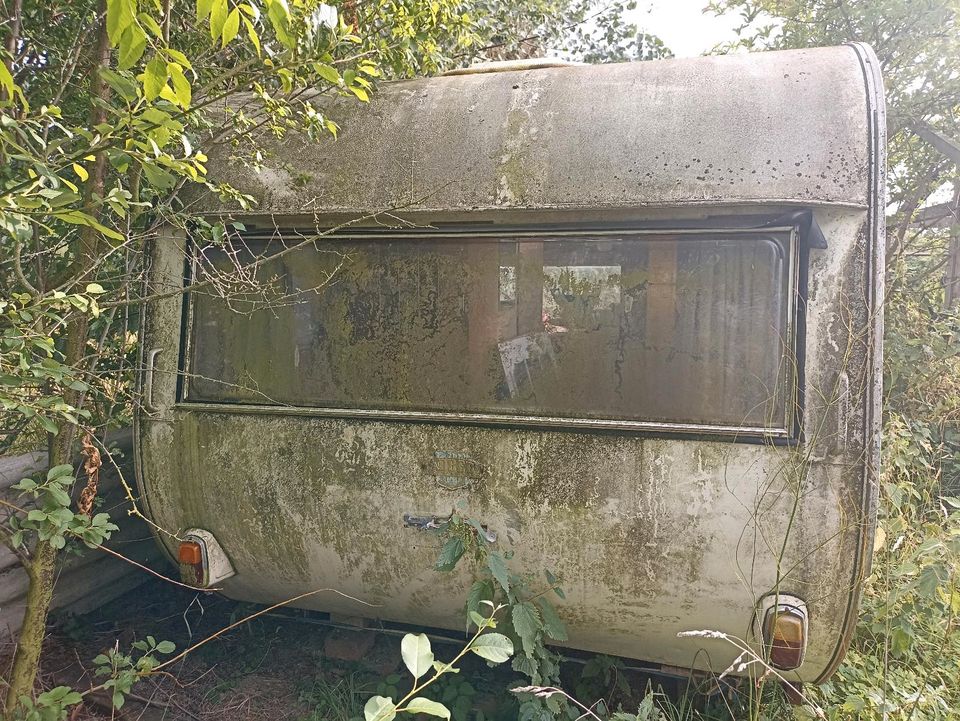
[{"left": 0, "top": 579, "right": 728, "bottom": 721}]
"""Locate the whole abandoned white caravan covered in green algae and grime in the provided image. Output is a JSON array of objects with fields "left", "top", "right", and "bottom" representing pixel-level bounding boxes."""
[{"left": 138, "top": 45, "right": 884, "bottom": 682}]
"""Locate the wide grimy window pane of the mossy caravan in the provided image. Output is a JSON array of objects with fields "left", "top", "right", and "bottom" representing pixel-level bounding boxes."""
[{"left": 188, "top": 232, "right": 793, "bottom": 429}]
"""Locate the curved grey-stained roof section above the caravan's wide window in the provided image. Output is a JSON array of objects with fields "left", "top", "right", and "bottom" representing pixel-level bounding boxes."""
[{"left": 201, "top": 45, "right": 880, "bottom": 215}]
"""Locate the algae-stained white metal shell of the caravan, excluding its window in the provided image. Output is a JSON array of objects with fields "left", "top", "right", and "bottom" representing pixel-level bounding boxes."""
[{"left": 138, "top": 46, "right": 884, "bottom": 681}]
